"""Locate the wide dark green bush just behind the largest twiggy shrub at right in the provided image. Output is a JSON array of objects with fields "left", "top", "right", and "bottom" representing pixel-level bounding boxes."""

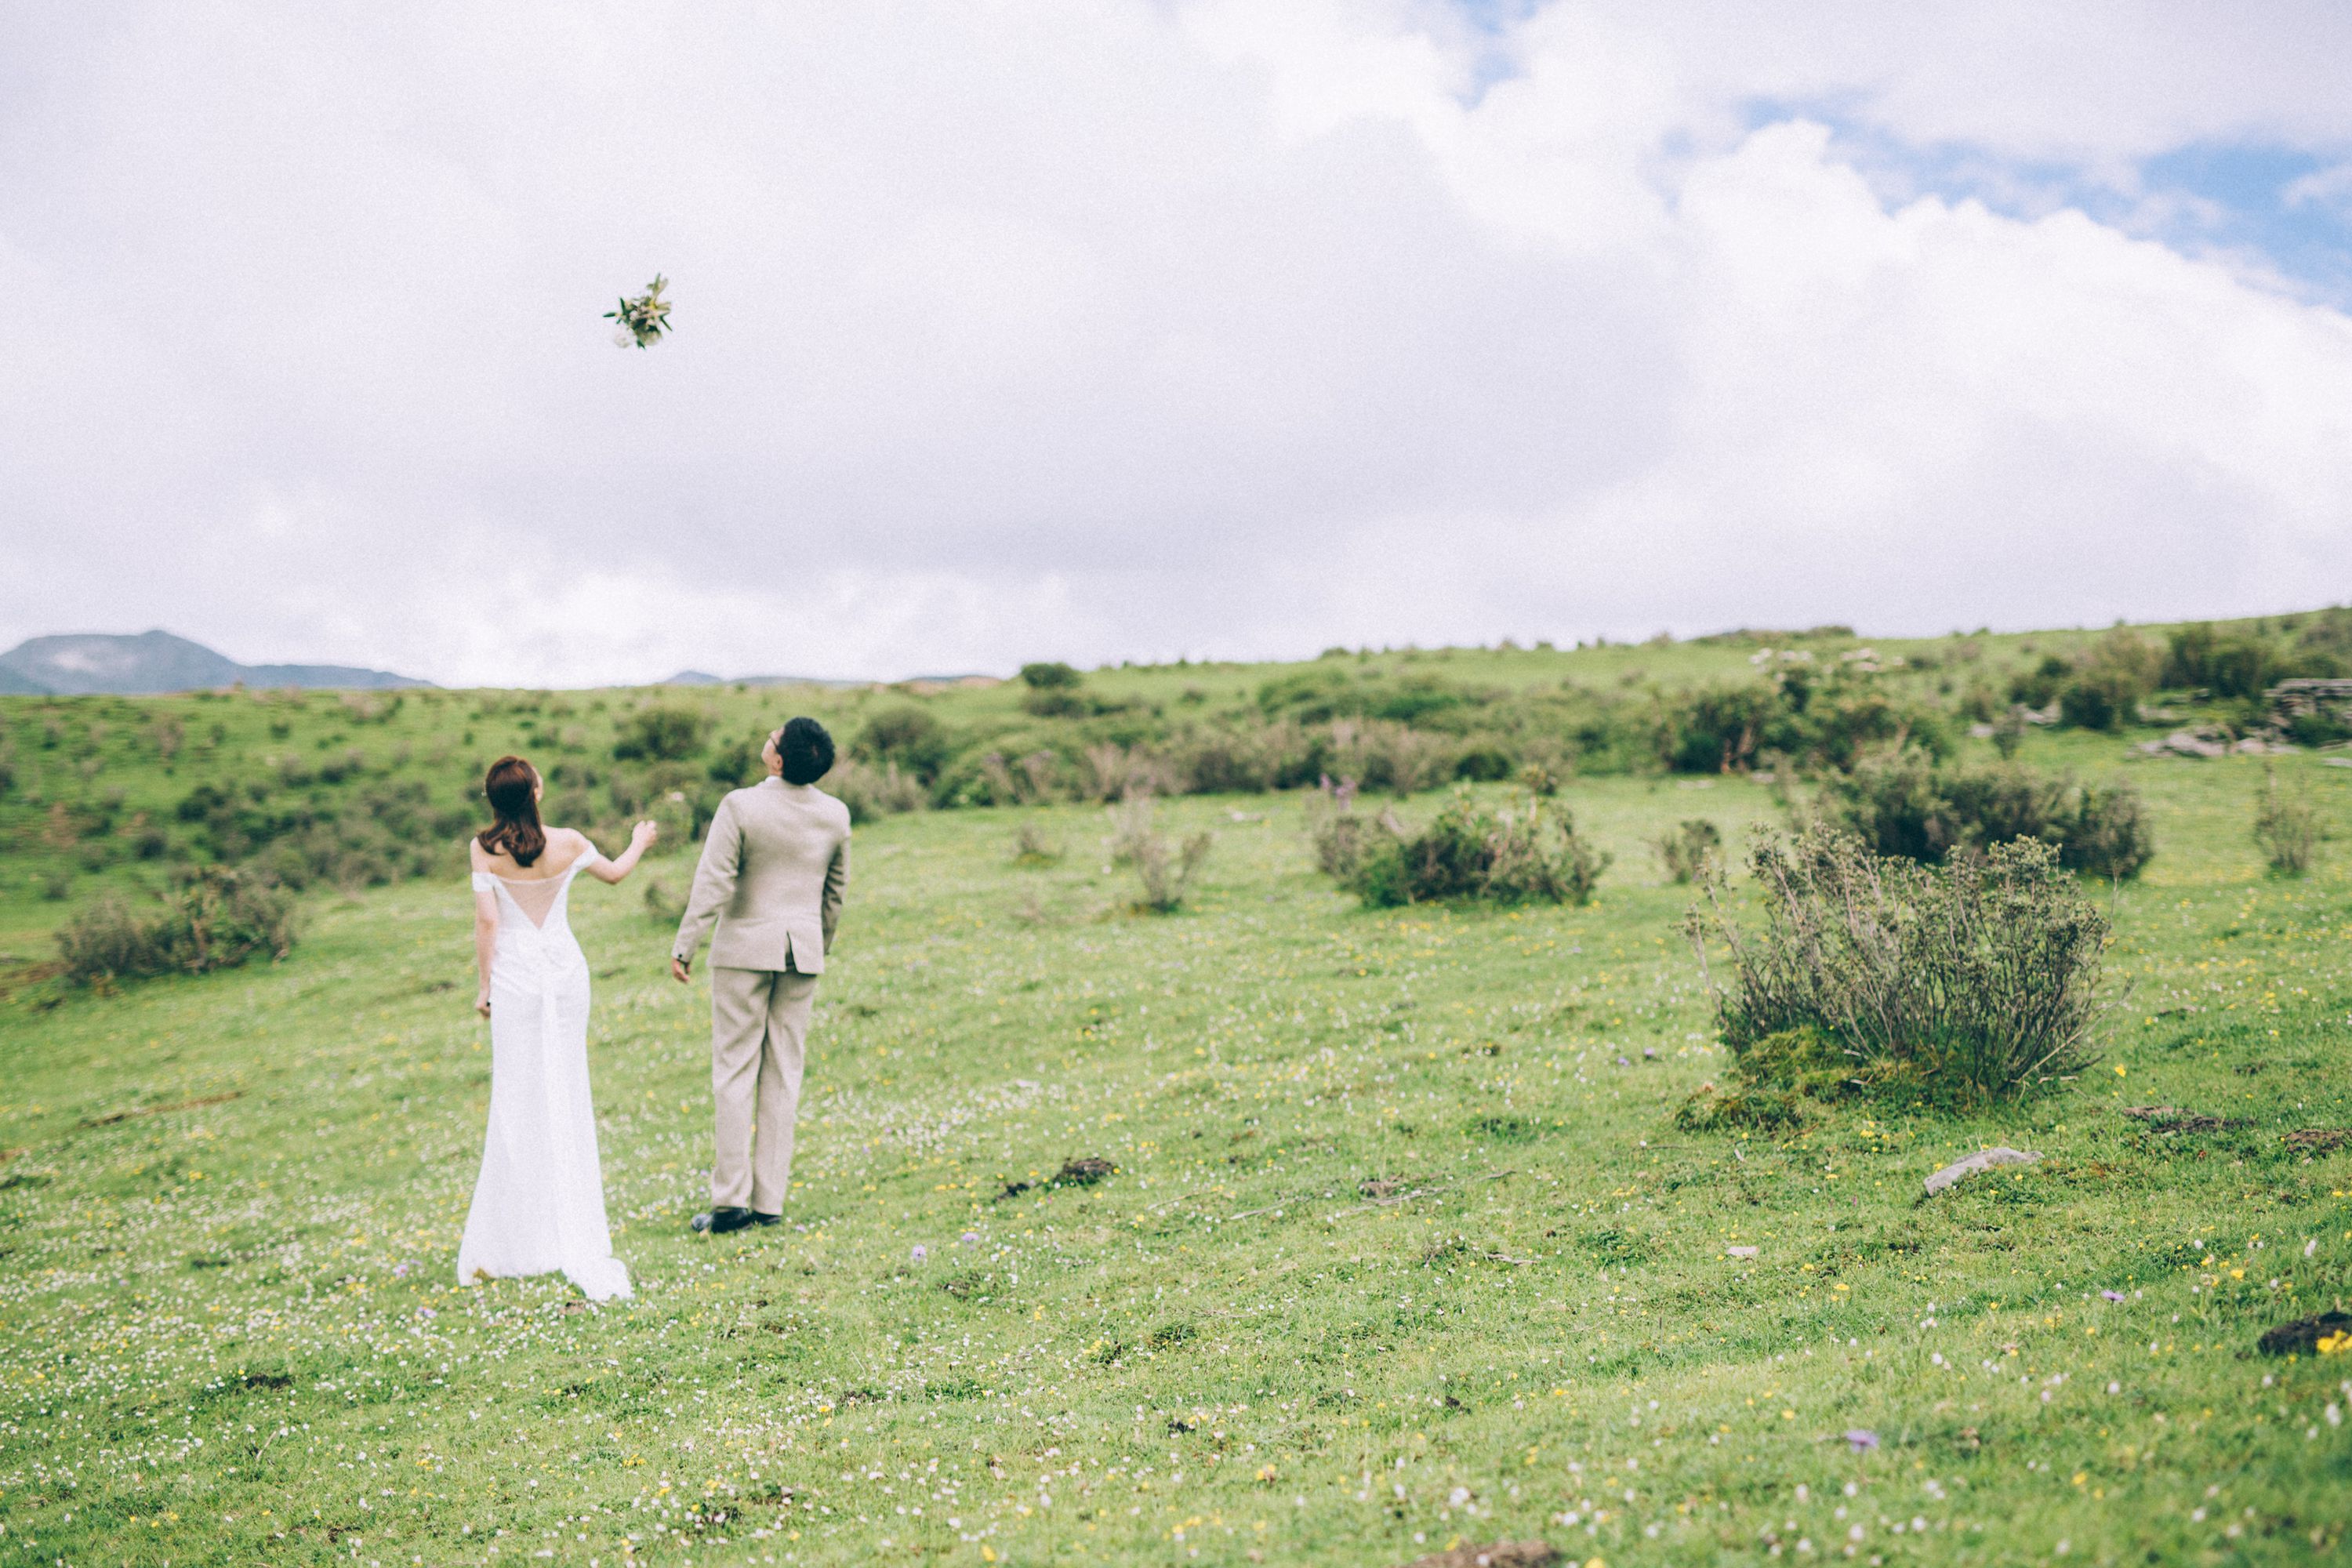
[{"left": 1823, "top": 748, "right": 2154, "bottom": 879}]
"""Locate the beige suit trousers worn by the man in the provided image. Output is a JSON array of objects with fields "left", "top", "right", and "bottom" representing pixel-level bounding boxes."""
[{"left": 710, "top": 966, "right": 816, "bottom": 1213}]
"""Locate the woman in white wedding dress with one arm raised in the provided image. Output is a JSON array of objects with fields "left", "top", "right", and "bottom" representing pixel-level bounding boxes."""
[{"left": 456, "top": 757, "right": 654, "bottom": 1300}]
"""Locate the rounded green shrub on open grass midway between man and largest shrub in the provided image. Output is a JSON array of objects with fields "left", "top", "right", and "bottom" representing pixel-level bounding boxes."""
[{"left": 1348, "top": 794, "right": 1609, "bottom": 907}]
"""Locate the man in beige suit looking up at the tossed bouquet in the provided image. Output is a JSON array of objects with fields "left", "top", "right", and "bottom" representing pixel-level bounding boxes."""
[{"left": 670, "top": 720, "right": 849, "bottom": 1234}]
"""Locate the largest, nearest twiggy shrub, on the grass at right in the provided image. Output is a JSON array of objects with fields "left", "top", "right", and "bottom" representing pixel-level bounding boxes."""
[{"left": 1689, "top": 827, "right": 2107, "bottom": 1107}]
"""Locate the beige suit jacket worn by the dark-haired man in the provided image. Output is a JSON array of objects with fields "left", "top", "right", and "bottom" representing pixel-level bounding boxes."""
[{"left": 670, "top": 779, "right": 849, "bottom": 975}]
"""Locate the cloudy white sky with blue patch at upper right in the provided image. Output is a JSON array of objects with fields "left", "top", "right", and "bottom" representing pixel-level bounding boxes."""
[{"left": 0, "top": 0, "right": 2352, "bottom": 684}]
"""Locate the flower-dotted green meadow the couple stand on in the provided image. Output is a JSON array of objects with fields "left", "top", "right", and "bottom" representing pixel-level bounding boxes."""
[{"left": 0, "top": 649, "right": 2352, "bottom": 1568}]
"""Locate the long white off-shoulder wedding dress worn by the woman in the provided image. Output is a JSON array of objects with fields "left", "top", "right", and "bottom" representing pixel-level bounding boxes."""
[{"left": 456, "top": 846, "right": 630, "bottom": 1300}]
